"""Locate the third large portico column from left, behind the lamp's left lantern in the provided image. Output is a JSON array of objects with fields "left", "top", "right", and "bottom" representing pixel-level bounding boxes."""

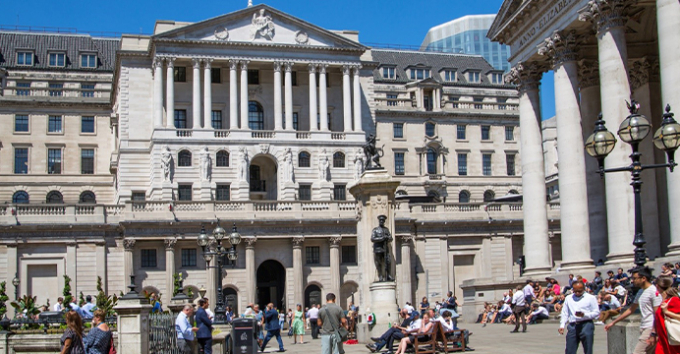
[{"left": 580, "top": 0, "right": 635, "bottom": 263}]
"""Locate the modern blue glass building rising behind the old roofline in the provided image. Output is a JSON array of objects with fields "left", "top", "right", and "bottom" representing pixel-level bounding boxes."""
[{"left": 420, "top": 15, "right": 510, "bottom": 72}]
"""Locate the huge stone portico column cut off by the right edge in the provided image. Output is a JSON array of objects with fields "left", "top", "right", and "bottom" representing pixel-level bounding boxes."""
[{"left": 650, "top": 0, "right": 680, "bottom": 256}]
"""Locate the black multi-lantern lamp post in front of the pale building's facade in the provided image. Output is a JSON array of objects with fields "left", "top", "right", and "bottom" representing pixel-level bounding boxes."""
[{"left": 197, "top": 220, "right": 241, "bottom": 324}]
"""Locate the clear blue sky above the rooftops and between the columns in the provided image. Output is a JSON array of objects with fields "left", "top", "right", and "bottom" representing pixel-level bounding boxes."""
[{"left": 0, "top": 0, "right": 555, "bottom": 118}]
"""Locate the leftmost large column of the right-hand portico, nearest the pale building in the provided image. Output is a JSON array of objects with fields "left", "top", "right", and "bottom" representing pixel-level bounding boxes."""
[{"left": 506, "top": 62, "right": 552, "bottom": 275}]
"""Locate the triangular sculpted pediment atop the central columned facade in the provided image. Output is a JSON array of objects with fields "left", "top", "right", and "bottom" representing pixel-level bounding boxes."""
[{"left": 154, "top": 4, "right": 366, "bottom": 50}]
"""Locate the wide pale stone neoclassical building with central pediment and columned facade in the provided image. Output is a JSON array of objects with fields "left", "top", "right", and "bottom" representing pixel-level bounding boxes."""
[{"left": 0, "top": 5, "right": 540, "bottom": 316}]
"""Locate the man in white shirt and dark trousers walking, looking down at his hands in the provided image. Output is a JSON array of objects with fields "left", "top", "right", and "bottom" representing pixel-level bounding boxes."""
[{"left": 558, "top": 282, "right": 600, "bottom": 354}]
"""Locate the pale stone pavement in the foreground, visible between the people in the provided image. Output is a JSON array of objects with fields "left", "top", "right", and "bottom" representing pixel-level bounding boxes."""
[{"left": 258, "top": 321, "right": 607, "bottom": 354}]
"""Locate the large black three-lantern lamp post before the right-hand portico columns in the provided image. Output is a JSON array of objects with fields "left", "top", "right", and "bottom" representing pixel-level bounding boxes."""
[{"left": 585, "top": 100, "right": 680, "bottom": 268}]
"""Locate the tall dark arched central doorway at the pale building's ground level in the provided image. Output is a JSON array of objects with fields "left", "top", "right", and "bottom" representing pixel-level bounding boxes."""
[{"left": 255, "top": 259, "right": 286, "bottom": 310}]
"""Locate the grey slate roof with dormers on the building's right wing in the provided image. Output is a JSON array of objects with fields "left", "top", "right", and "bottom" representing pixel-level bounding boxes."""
[{"left": 371, "top": 49, "right": 506, "bottom": 87}]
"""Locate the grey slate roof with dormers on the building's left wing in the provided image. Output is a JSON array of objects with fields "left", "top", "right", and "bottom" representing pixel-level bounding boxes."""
[{"left": 0, "top": 31, "right": 120, "bottom": 72}]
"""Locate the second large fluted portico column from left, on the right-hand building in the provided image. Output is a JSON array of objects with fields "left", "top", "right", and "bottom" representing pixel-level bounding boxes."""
[{"left": 538, "top": 31, "right": 593, "bottom": 269}]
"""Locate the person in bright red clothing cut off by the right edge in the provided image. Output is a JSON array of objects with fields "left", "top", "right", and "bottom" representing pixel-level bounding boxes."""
[{"left": 654, "top": 276, "right": 680, "bottom": 354}]
